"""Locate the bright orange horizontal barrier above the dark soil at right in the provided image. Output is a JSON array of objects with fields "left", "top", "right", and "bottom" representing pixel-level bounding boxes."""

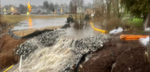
[{"left": 120, "top": 35, "right": 149, "bottom": 40}]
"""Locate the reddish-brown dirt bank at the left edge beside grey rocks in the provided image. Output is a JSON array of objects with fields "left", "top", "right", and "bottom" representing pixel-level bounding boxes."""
[{"left": 0, "top": 35, "right": 25, "bottom": 71}]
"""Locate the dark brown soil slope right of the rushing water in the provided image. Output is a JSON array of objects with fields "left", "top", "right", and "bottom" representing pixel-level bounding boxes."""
[{"left": 78, "top": 39, "right": 150, "bottom": 72}]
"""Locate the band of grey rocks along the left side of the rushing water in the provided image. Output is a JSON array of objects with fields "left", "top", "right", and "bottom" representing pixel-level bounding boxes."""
[{"left": 16, "top": 31, "right": 63, "bottom": 59}]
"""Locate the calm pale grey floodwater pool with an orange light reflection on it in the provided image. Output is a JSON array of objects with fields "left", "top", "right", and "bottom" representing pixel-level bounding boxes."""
[{"left": 13, "top": 18, "right": 66, "bottom": 30}]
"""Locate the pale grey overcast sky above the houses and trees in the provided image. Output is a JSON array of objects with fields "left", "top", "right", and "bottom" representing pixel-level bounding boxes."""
[{"left": 1, "top": 0, "right": 93, "bottom": 6}]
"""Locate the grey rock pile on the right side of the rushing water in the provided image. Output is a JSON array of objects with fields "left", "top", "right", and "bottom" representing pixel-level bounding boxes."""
[{"left": 72, "top": 35, "right": 108, "bottom": 54}]
